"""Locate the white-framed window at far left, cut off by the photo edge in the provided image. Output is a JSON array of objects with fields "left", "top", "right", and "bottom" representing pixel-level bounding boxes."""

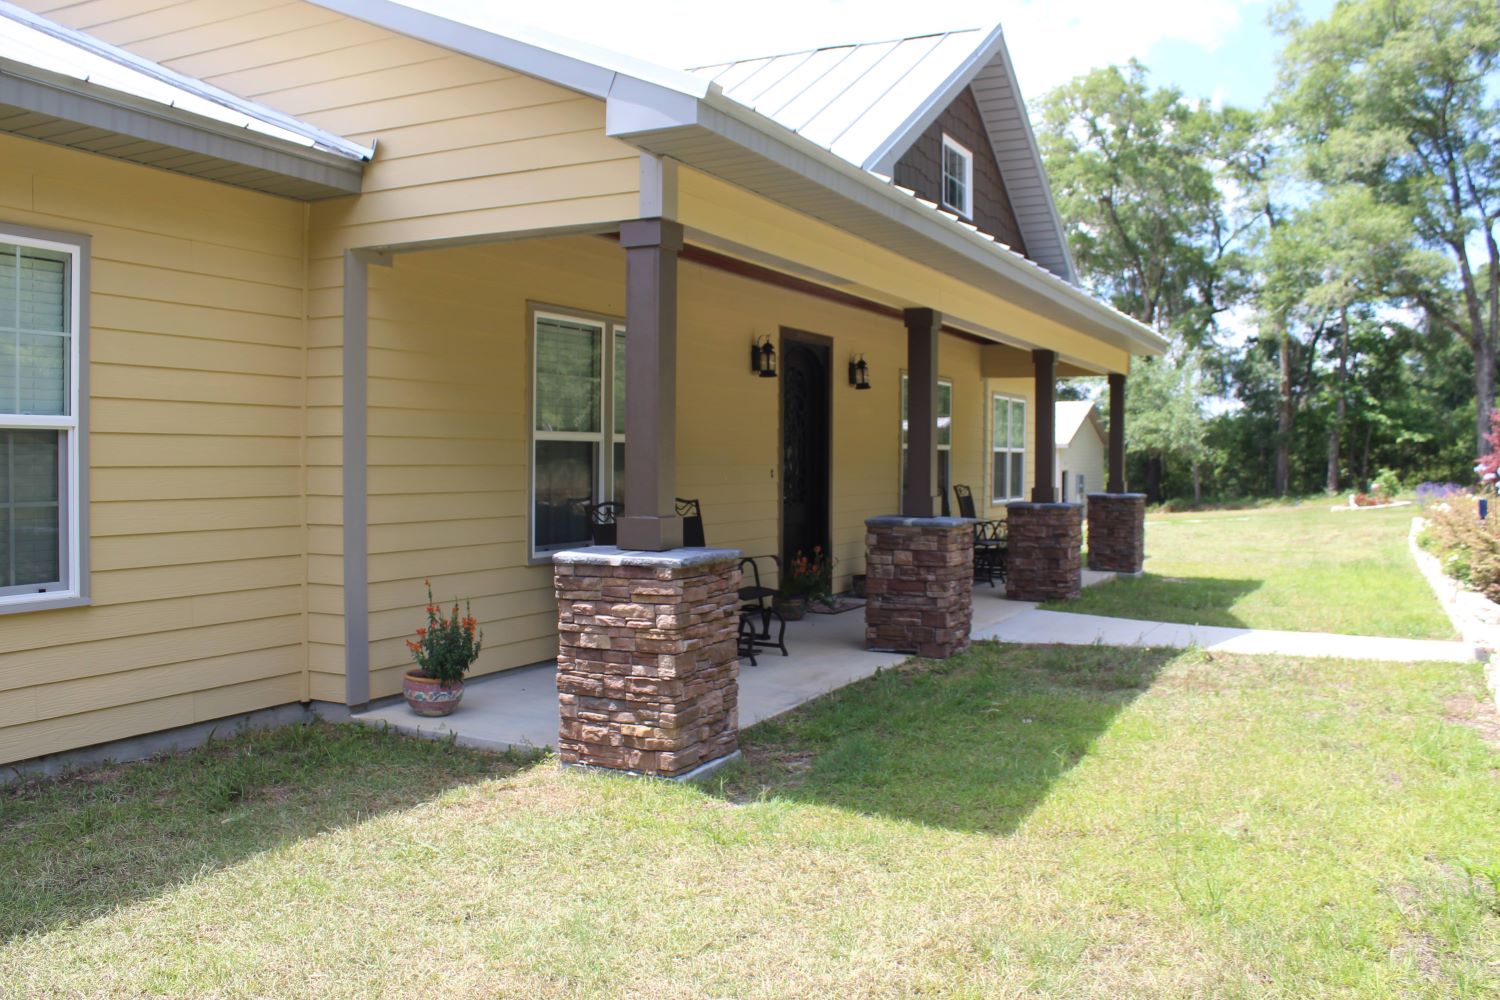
[{"left": 0, "top": 226, "right": 86, "bottom": 612}]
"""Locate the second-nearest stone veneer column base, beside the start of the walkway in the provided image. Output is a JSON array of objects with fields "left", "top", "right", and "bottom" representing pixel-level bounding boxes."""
[{"left": 864, "top": 517, "right": 974, "bottom": 660}]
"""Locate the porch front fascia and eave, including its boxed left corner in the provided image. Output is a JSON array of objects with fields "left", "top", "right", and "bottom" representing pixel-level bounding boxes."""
[{"left": 608, "top": 90, "right": 1167, "bottom": 355}]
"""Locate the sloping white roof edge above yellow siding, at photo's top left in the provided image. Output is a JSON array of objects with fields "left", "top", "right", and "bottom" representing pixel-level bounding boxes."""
[{"left": 309, "top": 0, "right": 711, "bottom": 97}]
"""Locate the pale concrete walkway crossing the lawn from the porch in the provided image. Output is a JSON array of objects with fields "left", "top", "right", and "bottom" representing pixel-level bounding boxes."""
[{"left": 974, "top": 597, "right": 1476, "bottom": 663}]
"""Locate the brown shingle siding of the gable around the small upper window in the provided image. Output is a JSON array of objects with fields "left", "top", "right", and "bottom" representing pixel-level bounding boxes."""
[{"left": 893, "top": 87, "right": 1026, "bottom": 253}]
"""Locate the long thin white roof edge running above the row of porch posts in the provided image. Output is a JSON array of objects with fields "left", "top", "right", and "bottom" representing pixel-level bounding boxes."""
[{"left": 680, "top": 91, "right": 1169, "bottom": 354}]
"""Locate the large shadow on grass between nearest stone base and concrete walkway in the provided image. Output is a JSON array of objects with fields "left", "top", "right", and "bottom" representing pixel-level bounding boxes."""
[{"left": 719, "top": 642, "right": 1179, "bottom": 835}]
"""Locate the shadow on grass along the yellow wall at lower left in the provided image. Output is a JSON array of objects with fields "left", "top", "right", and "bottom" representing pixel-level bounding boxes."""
[{"left": 0, "top": 723, "right": 540, "bottom": 943}]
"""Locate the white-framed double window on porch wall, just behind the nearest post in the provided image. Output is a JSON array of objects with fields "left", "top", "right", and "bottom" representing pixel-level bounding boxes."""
[{"left": 531, "top": 310, "right": 626, "bottom": 558}]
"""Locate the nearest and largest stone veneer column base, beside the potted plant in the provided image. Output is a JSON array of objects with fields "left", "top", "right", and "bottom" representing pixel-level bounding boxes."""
[{"left": 552, "top": 546, "right": 740, "bottom": 778}]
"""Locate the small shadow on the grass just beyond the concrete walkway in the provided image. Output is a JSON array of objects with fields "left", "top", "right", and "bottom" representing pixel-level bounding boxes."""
[{"left": 1041, "top": 573, "right": 1265, "bottom": 628}]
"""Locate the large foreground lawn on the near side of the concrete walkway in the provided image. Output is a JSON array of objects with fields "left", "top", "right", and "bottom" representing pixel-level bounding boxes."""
[{"left": 0, "top": 643, "right": 1500, "bottom": 999}]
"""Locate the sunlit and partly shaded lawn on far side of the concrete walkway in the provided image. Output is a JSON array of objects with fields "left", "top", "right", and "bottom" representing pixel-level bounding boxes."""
[{"left": 1044, "top": 502, "right": 1457, "bottom": 639}]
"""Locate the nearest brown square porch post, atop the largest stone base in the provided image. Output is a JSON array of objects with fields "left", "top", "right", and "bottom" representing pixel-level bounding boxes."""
[{"left": 618, "top": 219, "right": 683, "bottom": 552}]
